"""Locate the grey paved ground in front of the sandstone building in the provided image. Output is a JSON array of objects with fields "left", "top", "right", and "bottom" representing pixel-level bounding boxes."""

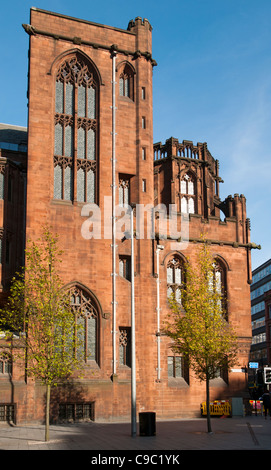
[{"left": 0, "top": 415, "right": 271, "bottom": 454}]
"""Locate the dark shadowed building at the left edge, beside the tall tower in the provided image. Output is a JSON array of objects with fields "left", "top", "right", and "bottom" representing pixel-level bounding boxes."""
[{"left": 0, "top": 124, "right": 27, "bottom": 297}]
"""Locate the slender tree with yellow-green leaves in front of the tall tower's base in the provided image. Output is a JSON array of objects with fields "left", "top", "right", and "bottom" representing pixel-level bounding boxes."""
[{"left": 0, "top": 228, "right": 81, "bottom": 441}]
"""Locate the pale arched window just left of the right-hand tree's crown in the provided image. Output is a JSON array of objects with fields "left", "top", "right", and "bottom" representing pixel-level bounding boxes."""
[{"left": 167, "top": 256, "right": 184, "bottom": 304}]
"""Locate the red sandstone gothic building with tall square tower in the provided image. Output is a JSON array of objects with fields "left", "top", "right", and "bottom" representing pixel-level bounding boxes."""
[{"left": 0, "top": 8, "right": 260, "bottom": 422}]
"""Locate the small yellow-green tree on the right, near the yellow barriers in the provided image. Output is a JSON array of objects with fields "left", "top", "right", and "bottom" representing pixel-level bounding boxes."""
[{"left": 165, "top": 242, "right": 237, "bottom": 432}]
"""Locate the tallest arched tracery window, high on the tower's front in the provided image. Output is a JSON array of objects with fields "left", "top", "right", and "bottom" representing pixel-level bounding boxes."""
[{"left": 54, "top": 54, "right": 98, "bottom": 202}]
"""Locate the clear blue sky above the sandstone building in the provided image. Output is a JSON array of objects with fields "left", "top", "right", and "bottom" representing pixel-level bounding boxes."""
[{"left": 0, "top": 0, "right": 271, "bottom": 269}]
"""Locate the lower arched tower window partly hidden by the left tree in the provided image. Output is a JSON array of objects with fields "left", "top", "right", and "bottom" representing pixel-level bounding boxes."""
[{"left": 70, "top": 286, "right": 99, "bottom": 362}]
